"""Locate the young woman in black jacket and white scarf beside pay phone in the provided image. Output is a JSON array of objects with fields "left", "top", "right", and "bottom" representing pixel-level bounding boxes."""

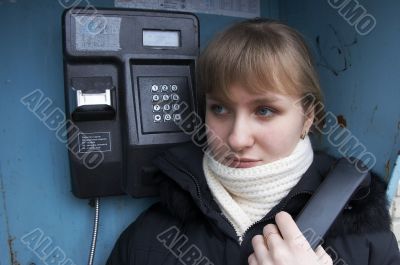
[{"left": 107, "top": 19, "right": 400, "bottom": 265}]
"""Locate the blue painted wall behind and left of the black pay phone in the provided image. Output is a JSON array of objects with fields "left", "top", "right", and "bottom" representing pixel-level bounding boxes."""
[{"left": 0, "top": 0, "right": 278, "bottom": 265}]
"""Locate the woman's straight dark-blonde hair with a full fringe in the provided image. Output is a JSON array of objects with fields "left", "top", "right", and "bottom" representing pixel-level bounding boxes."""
[{"left": 197, "top": 19, "right": 324, "bottom": 129}]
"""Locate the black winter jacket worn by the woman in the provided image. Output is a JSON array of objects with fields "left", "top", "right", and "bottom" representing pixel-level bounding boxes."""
[{"left": 107, "top": 144, "right": 400, "bottom": 265}]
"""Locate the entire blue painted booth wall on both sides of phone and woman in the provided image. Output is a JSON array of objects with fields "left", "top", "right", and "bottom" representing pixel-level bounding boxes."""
[{"left": 0, "top": 0, "right": 400, "bottom": 265}]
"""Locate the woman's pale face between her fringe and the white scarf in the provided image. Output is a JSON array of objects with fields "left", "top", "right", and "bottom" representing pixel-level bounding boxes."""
[{"left": 206, "top": 85, "right": 314, "bottom": 168}]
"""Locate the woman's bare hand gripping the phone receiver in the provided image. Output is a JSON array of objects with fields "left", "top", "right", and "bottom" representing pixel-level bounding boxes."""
[{"left": 248, "top": 212, "right": 332, "bottom": 265}]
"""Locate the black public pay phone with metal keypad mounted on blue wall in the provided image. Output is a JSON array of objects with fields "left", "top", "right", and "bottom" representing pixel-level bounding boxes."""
[{"left": 63, "top": 8, "right": 199, "bottom": 198}]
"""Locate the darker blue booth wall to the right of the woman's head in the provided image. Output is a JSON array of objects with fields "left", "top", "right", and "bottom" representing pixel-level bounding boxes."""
[{"left": 279, "top": 0, "right": 400, "bottom": 184}]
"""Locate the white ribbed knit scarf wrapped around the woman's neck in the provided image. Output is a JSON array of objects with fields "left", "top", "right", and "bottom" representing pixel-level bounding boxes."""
[{"left": 203, "top": 137, "right": 313, "bottom": 241}]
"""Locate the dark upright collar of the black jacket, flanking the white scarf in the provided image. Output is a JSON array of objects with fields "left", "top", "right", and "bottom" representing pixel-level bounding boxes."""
[{"left": 154, "top": 143, "right": 334, "bottom": 240}]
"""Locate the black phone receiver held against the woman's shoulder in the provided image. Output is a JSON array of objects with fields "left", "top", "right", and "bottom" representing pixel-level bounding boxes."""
[{"left": 296, "top": 158, "right": 369, "bottom": 250}]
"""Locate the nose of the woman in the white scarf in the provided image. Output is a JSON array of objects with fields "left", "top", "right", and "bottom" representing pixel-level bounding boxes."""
[{"left": 228, "top": 117, "right": 254, "bottom": 152}]
